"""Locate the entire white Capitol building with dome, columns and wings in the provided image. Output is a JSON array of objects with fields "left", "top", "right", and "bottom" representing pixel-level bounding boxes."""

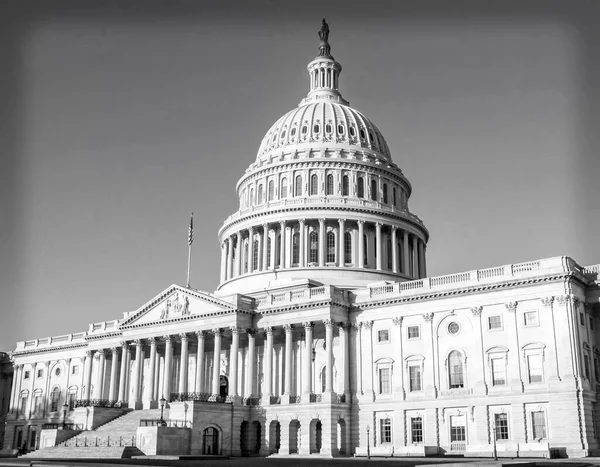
[{"left": 4, "top": 21, "right": 600, "bottom": 457}]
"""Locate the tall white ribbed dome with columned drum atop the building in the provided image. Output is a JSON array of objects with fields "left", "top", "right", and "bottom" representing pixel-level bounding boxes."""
[{"left": 218, "top": 22, "right": 429, "bottom": 293}]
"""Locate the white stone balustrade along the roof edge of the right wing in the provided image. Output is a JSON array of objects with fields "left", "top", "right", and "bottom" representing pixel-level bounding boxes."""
[{"left": 364, "top": 257, "right": 600, "bottom": 302}]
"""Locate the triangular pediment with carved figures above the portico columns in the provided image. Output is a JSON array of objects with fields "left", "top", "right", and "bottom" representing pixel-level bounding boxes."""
[{"left": 119, "top": 285, "right": 236, "bottom": 328}]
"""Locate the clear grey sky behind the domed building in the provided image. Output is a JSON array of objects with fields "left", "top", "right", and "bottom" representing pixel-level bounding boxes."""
[{"left": 0, "top": 0, "right": 600, "bottom": 351}]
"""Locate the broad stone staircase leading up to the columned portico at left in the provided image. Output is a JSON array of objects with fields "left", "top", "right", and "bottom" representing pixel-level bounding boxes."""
[{"left": 22, "top": 409, "right": 168, "bottom": 459}]
